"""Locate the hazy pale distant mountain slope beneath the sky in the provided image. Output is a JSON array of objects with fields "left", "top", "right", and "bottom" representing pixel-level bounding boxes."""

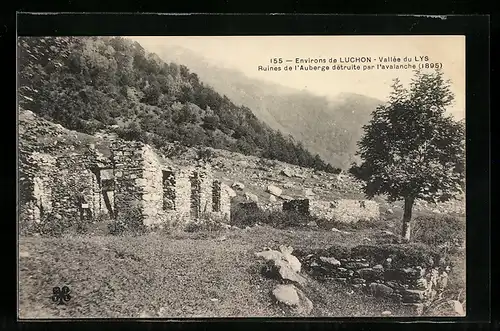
[{"left": 150, "top": 45, "right": 383, "bottom": 169}]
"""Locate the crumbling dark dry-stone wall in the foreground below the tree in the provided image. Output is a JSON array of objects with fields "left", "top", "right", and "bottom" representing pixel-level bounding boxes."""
[{"left": 299, "top": 246, "right": 451, "bottom": 314}]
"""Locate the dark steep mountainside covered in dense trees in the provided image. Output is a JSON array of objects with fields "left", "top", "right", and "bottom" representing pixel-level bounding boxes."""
[{"left": 18, "top": 37, "right": 338, "bottom": 172}]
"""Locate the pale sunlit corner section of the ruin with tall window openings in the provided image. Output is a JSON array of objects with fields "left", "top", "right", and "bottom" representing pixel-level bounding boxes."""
[{"left": 112, "top": 141, "right": 230, "bottom": 230}]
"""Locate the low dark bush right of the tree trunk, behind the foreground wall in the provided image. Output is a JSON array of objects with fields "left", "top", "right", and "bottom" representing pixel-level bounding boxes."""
[{"left": 412, "top": 216, "right": 465, "bottom": 247}]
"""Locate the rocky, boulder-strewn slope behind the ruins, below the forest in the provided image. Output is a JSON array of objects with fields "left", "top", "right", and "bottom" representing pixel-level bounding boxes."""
[{"left": 19, "top": 109, "right": 464, "bottom": 219}]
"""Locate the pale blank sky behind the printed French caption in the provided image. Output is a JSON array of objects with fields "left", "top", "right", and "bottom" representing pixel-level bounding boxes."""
[{"left": 129, "top": 36, "right": 465, "bottom": 119}]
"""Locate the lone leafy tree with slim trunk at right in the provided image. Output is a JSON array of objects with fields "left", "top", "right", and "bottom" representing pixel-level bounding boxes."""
[{"left": 351, "top": 70, "right": 465, "bottom": 241}]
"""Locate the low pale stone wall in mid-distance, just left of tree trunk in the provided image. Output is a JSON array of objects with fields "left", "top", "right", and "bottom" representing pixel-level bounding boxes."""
[{"left": 309, "top": 199, "right": 380, "bottom": 223}]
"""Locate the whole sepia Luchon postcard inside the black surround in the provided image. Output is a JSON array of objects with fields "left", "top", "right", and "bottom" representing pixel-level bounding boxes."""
[{"left": 17, "top": 35, "right": 466, "bottom": 319}]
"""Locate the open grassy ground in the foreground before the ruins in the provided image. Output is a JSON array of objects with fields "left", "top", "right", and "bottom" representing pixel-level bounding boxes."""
[{"left": 19, "top": 227, "right": 409, "bottom": 318}]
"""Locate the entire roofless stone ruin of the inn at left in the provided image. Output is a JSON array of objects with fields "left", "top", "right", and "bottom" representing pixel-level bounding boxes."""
[{"left": 20, "top": 141, "right": 230, "bottom": 231}]
